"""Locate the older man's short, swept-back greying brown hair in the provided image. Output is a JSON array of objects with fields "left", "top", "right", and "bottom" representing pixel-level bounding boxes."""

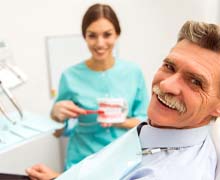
[{"left": 177, "top": 21, "right": 220, "bottom": 52}]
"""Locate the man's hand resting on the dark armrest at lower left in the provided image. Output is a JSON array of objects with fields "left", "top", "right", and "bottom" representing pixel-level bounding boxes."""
[{"left": 26, "top": 164, "right": 60, "bottom": 180}]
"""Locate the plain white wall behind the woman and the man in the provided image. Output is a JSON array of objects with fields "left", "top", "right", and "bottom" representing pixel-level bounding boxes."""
[{"left": 0, "top": 0, "right": 220, "bottom": 114}]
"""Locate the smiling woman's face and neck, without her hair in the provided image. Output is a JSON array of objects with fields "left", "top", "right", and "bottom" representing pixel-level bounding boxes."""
[{"left": 85, "top": 18, "right": 118, "bottom": 71}]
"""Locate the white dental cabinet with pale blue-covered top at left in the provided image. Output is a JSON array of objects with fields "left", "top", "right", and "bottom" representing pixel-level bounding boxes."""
[{"left": 0, "top": 112, "right": 63, "bottom": 174}]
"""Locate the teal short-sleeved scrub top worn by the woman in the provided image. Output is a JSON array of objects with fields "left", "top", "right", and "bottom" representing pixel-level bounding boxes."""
[{"left": 56, "top": 59, "right": 149, "bottom": 170}]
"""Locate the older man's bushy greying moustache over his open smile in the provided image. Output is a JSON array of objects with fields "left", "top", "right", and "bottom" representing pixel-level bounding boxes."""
[{"left": 153, "top": 86, "right": 186, "bottom": 113}]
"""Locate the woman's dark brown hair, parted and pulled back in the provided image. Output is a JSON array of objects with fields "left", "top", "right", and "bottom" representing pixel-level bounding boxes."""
[{"left": 82, "top": 4, "right": 121, "bottom": 38}]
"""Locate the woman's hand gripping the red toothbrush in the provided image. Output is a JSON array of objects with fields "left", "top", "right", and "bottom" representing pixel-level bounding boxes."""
[{"left": 51, "top": 101, "right": 86, "bottom": 122}]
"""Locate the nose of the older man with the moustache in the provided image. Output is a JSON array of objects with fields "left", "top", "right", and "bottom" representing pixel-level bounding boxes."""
[{"left": 160, "top": 74, "right": 182, "bottom": 95}]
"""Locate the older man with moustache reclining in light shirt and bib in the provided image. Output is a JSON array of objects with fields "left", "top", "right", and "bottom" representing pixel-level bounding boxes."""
[{"left": 27, "top": 21, "right": 220, "bottom": 180}]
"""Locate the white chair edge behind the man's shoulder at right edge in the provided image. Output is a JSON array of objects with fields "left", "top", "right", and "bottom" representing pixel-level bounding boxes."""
[{"left": 211, "top": 117, "right": 220, "bottom": 180}]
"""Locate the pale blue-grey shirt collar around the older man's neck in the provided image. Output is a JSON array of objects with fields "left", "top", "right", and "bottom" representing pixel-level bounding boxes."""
[{"left": 139, "top": 125, "right": 208, "bottom": 148}]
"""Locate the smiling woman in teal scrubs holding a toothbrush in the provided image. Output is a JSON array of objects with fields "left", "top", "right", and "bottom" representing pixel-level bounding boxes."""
[{"left": 26, "top": 4, "right": 148, "bottom": 179}]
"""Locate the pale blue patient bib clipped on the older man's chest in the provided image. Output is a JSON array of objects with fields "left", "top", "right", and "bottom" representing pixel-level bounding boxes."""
[{"left": 56, "top": 128, "right": 142, "bottom": 180}]
